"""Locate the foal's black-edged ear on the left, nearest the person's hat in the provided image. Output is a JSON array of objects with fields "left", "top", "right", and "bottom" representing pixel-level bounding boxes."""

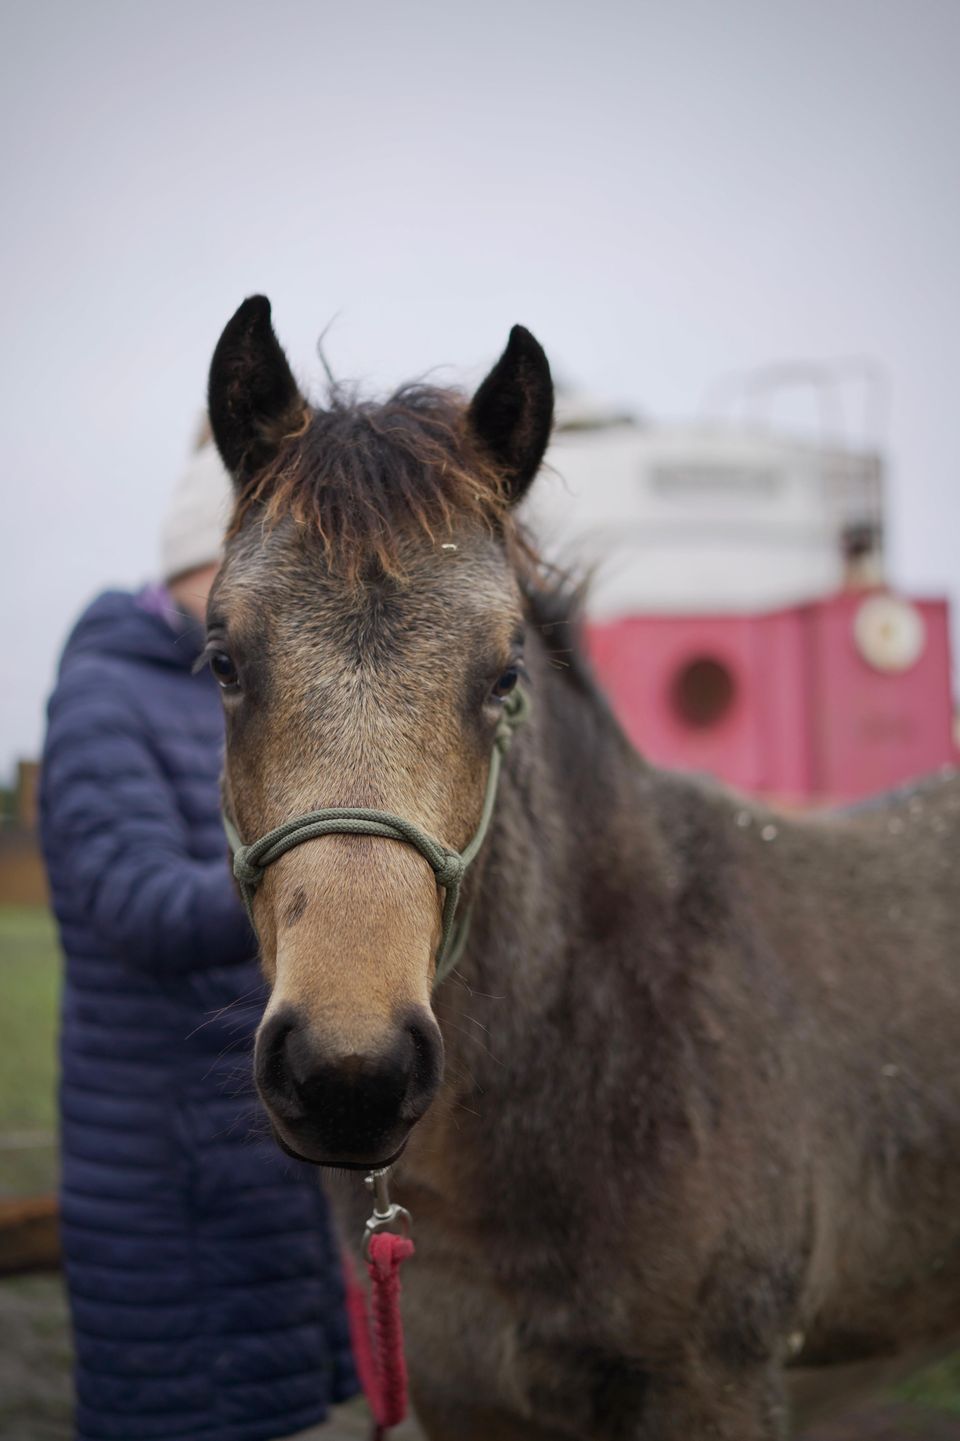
[{"left": 208, "top": 295, "right": 308, "bottom": 488}]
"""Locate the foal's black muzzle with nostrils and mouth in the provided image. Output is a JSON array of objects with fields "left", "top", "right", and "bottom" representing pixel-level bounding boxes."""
[{"left": 255, "top": 1006, "right": 443, "bottom": 1169}]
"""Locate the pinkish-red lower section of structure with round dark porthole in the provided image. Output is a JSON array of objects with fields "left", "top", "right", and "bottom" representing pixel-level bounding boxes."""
[{"left": 590, "top": 589, "right": 956, "bottom": 803}]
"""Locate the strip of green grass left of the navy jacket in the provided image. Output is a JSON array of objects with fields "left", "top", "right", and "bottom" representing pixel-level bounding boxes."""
[{"left": 0, "top": 906, "right": 61, "bottom": 1196}]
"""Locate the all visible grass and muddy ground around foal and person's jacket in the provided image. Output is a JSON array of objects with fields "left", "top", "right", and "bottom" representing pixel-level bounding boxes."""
[{"left": 0, "top": 908, "right": 960, "bottom": 1441}]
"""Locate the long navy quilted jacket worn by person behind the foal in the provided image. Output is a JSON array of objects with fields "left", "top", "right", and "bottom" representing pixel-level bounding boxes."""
[{"left": 40, "top": 592, "right": 355, "bottom": 1441}]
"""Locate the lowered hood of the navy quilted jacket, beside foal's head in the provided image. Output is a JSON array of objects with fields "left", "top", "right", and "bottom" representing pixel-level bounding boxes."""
[{"left": 61, "top": 591, "right": 203, "bottom": 670}]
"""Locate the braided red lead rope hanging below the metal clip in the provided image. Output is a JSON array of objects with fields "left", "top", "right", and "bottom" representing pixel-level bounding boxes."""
[{"left": 343, "top": 1231, "right": 414, "bottom": 1441}]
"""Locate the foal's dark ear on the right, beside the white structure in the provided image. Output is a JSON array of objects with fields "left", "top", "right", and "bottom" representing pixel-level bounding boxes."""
[{"left": 468, "top": 326, "right": 554, "bottom": 504}]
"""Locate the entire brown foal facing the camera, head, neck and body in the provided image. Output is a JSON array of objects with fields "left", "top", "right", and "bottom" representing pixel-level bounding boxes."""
[{"left": 206, "top": 298, "right": 960, "bottom": 1441}]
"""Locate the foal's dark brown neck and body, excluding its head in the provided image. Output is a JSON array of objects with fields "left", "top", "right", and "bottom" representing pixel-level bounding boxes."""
[{"left": 337, "top": 622, "right": 960, "bottom": 1441}]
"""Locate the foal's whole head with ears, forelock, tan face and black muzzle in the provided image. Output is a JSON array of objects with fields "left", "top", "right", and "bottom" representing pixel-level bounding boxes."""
[{"left": 208, "top": 297, "right": 552, "bottom": 1166}]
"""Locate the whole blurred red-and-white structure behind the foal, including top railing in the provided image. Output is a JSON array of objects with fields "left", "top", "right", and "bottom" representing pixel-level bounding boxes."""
[{"left": 532, "top": 367, "right": 957, "bottom": 804}]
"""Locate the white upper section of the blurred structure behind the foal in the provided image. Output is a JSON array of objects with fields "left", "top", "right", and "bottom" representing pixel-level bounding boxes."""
[{"left": 526, "top": 416, "right": 884, "bottom": 618}]
